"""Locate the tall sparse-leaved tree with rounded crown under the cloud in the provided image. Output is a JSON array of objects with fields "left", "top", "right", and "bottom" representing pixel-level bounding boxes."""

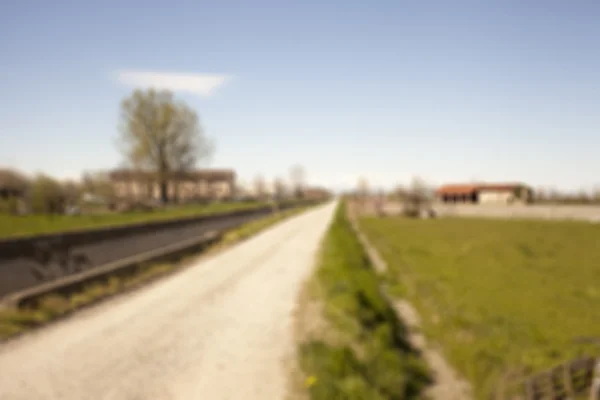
[{"left": 120, "top": 89, "right": 214, "bottom": 202}]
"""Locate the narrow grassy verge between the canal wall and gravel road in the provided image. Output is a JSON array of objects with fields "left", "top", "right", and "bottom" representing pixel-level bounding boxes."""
[{"left": 0, "top": 207, "right": 309, "bottom": 340}]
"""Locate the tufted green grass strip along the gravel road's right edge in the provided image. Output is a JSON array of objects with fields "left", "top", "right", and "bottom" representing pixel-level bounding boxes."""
[{"left": 298, "top": 204, "right": 429, "bottom": 400}]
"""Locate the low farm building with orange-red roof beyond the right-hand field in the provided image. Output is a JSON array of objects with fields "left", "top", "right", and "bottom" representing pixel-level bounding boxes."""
[{"left": 435, "top": 183, "right": 533, "bottom": 204}]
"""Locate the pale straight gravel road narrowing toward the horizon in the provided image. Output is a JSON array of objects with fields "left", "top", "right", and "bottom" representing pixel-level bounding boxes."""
[{"left": 0, "top": 204, "right": 334, "bottom": 400}]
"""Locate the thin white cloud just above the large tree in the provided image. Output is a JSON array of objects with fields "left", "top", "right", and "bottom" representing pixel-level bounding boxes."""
[{"left": 118, "top": 70, "right": 230, "bottom": 96}]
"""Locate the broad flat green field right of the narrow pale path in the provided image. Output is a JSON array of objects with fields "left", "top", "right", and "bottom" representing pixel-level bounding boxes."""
[{"left": 360, "top": 218, "right": 600, "bottom": 398}]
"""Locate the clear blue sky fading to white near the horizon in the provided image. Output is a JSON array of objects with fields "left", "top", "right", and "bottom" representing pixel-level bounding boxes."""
[{"left": 0, "top": 0, "right": 600, "bottom": 190}]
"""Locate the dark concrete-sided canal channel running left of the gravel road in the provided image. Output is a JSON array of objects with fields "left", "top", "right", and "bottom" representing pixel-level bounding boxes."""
[{"left": 0, "top": 202, "right": 313, "bottom": 305}]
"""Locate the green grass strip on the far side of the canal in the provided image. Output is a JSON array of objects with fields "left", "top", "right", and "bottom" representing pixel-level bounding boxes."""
[{"left": 0, "top": 203, "right": 266, "bottom": 237}]
